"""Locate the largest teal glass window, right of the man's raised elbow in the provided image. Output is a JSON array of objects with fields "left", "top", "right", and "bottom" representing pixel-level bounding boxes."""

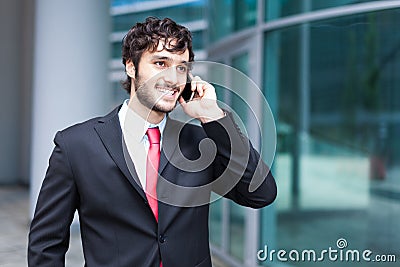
[{"left": 264, "top": 7, "right": 400, "bottom": 266}]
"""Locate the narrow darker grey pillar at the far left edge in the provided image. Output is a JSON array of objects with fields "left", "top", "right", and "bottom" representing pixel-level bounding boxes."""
[{"left": 0, "top": 1, "right": 23, "bottom": 185}]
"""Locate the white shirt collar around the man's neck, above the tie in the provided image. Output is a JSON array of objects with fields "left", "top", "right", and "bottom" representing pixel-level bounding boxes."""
[{"left": 118, "top": 99, "right": 167, "bottom": 142}]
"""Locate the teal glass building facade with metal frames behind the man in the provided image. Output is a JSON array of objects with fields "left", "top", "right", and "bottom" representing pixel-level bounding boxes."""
[{"left": 110, "top": 0, "right": 400, "bottom": 267}]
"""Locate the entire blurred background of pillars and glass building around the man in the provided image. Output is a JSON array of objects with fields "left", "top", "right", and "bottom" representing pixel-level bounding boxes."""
[{"left": 0, "top": 0, "right": 400, "bottom": 267}]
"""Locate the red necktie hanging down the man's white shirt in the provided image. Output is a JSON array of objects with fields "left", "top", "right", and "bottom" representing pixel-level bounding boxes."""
[{"left": 146, "top": 127, "right": 160, "bottom": 222}]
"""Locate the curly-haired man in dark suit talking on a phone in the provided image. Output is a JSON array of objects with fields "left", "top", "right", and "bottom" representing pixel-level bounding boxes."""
[{"left": 28, "top": 18, "right": 276, "bottom": 267}]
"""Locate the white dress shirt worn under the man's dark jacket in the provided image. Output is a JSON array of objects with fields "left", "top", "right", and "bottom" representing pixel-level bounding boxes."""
[{"left": 118, "top": 99, "right": 167, "bottom": 188}]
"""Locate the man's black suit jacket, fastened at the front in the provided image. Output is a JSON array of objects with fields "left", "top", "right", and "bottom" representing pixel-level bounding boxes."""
[{"left": 28, "top": 105, "right": 276, "bottom": 267}]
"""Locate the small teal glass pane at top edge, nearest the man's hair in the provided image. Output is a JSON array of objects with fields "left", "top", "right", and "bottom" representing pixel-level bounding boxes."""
[{"left": 209, "top": 0, "right": 257, "bottom": 41}]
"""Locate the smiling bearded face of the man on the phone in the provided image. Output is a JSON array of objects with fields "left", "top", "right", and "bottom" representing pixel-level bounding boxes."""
[{"left": 127, "top": 41, "right": 189, "bottom": 119}]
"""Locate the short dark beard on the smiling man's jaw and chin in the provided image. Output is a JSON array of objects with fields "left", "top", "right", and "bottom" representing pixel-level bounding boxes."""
[{"left": 134, "top": 77, "right": 181, "bottom": 113}]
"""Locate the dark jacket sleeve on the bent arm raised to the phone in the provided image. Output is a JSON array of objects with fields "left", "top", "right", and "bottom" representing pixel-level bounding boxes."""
[{"left": 202, "top": 113, "right": 277, "bottom": 208}]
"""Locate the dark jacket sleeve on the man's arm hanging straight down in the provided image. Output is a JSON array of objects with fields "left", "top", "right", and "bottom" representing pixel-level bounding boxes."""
[{"left": 28, "top": 132, "right": 78, "bottom": 267}]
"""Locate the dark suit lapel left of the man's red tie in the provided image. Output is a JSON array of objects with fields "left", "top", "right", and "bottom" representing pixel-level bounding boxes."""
[{"left": 95, "top": 108, "right": 146, "bottom": 199}]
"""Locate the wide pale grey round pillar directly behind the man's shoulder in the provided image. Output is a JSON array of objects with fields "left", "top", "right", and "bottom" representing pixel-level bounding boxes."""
[{"left": 30, "top": 0, "right": 111, "bottom": 217}]
